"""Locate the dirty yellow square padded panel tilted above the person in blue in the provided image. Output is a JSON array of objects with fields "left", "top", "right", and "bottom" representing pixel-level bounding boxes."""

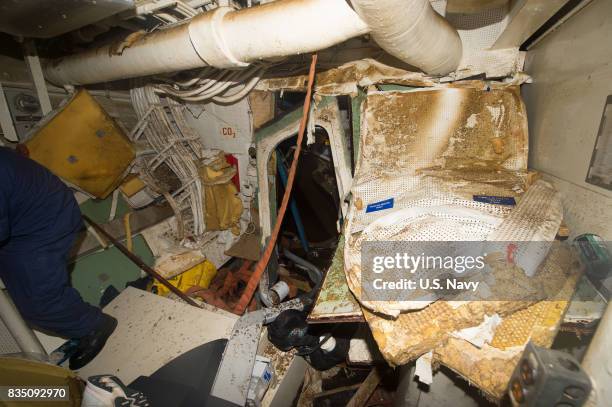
[{"left": 25, "top": 90, "right": 135, "bottom": 198}]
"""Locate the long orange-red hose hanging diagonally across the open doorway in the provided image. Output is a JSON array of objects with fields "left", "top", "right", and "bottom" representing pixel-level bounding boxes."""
[{"left": 234, "top": 54, "right": 317, "bottom": 315}]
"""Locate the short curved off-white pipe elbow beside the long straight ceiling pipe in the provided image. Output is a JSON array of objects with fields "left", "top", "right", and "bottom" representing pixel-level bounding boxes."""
[{"left": 351, "top": 0, "right": 463, "bottom": 75}]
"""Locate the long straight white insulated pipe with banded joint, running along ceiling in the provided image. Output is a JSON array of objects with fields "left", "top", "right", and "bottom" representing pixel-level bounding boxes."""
[{"left": 45, "top": 0, "right": 369, "bottom": 85}]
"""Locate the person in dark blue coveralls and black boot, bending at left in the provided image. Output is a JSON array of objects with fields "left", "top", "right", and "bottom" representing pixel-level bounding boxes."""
[{"left": 0, "top": 147, "right": 117, "bottom": 369}]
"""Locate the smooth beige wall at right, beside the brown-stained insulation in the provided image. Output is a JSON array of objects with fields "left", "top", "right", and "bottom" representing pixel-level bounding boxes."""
[{"left": 523, "top": 0, "right": 612, "bottom": 240}]
